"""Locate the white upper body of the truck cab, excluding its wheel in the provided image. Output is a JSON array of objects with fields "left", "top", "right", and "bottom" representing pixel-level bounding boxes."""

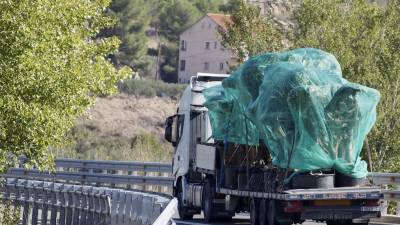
[{"left": 166, "top": 73, "right": 229, "bottom": 179}]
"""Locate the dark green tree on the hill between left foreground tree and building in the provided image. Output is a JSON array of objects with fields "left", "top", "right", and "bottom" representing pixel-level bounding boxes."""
[{"left": 102, "top": 0, "right": 150, "bottom": 71}]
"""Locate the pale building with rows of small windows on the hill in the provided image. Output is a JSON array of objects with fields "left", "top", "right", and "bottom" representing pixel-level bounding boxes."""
[{"left": 178, "top": 13, "right": 233, "bottom": 83}]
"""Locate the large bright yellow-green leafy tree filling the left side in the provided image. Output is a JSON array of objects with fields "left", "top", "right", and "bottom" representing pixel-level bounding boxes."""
[{"left": 0, "top": 0, "right": 129, "bottom": 172}]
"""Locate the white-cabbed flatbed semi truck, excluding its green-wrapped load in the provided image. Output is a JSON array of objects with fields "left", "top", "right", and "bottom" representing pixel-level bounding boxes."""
[{"left": 165, "top": 73, "right": 383, "bottom": 225}]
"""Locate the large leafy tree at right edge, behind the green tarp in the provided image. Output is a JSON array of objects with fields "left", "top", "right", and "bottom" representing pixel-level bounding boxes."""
[{"left": 294, "top": 0, "right": 400, "bottom": 170}]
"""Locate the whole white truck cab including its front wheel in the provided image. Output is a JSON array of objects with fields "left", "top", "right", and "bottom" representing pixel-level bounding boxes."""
[{"left": 165, "top": 73, "right": 229, "bottom": 218}]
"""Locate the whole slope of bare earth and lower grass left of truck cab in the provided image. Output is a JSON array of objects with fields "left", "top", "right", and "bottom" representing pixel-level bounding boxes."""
[{"left": 53, "top": 94, "right": 177, "bottom": 161}]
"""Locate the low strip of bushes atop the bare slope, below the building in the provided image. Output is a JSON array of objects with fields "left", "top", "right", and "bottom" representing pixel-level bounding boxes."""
[{"left": 119, "top": 79, "right": 186, "bottom": 99}]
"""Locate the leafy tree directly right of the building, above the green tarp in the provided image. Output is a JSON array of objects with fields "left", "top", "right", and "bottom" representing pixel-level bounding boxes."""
[{"left": 219, "top": 0, "right": 283, "bottom": 62}]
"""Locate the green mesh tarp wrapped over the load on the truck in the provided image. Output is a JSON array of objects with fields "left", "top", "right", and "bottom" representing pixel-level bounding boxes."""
[{"left": 203, "top": 49, "right": 380, "bottom": 178}]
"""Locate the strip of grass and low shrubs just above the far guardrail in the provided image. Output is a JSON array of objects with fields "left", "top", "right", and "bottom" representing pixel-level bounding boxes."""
[{"left": 52, "top": 123, "right": 172, "bottom": 162}]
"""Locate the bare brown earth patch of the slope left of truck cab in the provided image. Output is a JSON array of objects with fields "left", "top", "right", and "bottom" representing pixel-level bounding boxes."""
[{"left": 85, "top": 94, "right": 176, "bottom": 138}]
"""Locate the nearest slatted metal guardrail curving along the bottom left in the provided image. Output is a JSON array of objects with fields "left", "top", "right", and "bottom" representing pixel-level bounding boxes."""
[{"left": 1, "top": 178, "right": 170, "bottom": 225}]
